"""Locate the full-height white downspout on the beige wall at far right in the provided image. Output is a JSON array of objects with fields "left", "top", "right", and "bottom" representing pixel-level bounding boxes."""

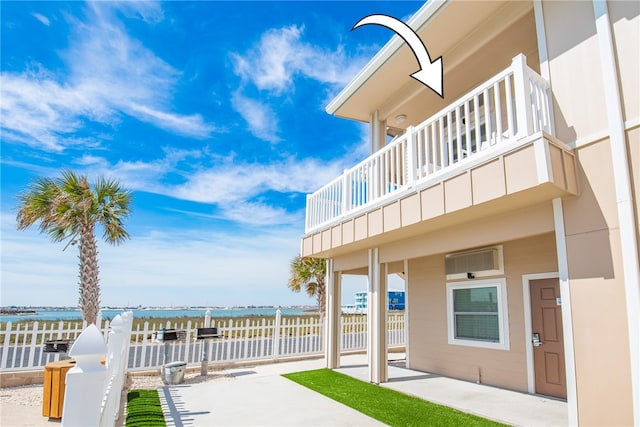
[{"left": 593, "top": 0, "right": 640, "bottom": 426}]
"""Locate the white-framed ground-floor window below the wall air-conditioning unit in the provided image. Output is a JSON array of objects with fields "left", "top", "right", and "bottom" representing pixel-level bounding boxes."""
[{"left": 447, "top": 279, "right": 509, "bottom": 350}]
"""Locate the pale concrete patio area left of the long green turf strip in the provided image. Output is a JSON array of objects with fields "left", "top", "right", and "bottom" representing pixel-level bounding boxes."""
[{"left": 160, "top": 359, "right": 385, "bottom": 427}]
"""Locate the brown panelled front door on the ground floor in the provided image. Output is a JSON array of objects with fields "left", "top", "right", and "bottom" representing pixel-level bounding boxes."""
[{"left": 529, "top": 279, "right": 567, "bottom": 399}]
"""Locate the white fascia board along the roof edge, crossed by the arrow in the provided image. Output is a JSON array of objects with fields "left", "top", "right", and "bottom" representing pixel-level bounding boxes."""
[{"left": 325, "top": 0, "right": 451, "bottom": 115}]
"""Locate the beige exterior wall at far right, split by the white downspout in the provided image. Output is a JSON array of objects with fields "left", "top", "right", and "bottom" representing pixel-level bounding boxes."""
[{"left": 543, "top": 0, "right": 640, "bottom": 425}]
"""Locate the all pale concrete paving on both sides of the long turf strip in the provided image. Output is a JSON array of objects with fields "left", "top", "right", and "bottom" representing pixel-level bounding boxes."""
[{"left": 160, "top": 354, "right": 567, "bottom": 427}]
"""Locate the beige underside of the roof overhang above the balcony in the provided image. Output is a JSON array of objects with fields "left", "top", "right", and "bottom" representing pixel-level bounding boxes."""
[{"left": 328, "top": 0, "right": 537, "bottom": 127}]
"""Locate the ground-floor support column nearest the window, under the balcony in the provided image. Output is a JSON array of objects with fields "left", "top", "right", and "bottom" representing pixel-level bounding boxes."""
[{"left": 367, "top": 248, "right": 387, "bottom": 384}]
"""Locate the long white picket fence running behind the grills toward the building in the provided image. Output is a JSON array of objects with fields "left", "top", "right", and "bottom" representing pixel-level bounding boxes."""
[{"left": 0, "top": 311, "right": 405, "bottom": 372}]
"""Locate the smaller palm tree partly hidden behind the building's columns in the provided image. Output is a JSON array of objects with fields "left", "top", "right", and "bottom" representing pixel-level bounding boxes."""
[{"left": 289, "top": 256, "right": 327, "bottom": 322}]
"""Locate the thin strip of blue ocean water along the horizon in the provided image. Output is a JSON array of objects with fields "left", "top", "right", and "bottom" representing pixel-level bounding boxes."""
[{"left": 0, "top": 307, "right": 312, "bottom": 322}]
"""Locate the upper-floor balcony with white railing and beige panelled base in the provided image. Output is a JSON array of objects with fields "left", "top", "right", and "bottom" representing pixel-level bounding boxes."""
[{"left": 303, "top": 54, "right": 577, "bottom": 247}]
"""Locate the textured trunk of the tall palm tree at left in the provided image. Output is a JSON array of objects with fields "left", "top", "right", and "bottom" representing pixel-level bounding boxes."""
[{"left": 79, "top": 224, "right": 100, "bottom": 324}]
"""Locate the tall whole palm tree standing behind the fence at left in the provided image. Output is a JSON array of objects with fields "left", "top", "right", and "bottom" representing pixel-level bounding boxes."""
[{"left": 16, "top": 169, "right": 131, "bottom": 324}]
